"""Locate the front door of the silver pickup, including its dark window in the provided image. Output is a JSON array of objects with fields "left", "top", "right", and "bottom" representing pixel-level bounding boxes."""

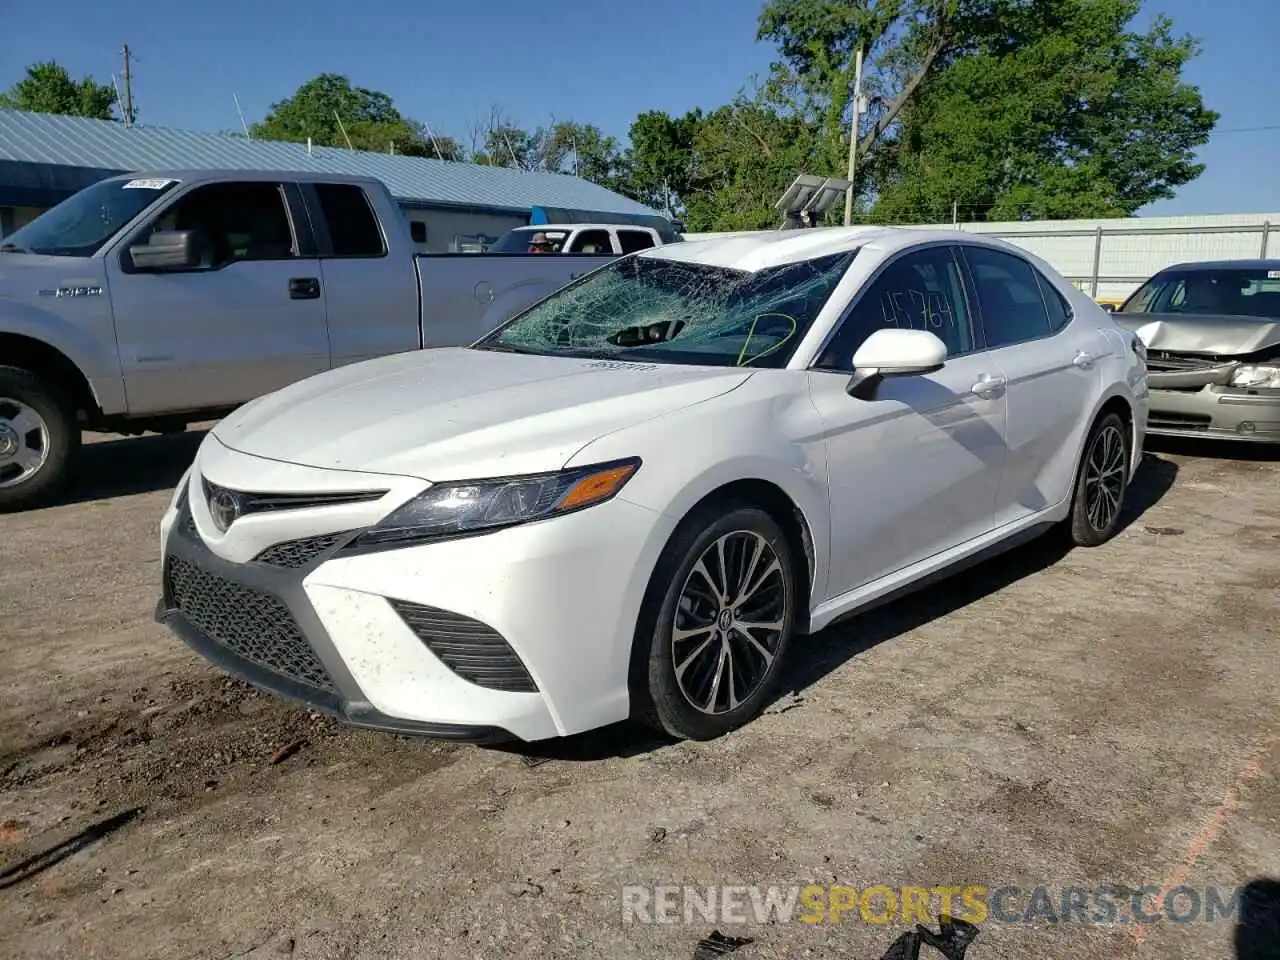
[{"left": 106, "top": 180, "right": 330, "bottom": 416}]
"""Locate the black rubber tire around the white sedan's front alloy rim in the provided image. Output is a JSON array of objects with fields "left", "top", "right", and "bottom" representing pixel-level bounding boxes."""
[{"left": 632, "top": 504, "right": 800, "bottom": 740}]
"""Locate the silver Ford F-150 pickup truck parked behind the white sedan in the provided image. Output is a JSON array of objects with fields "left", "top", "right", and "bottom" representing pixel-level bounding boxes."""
[{"left": 0, "top": 170, "right": 624, "bottom": 512}]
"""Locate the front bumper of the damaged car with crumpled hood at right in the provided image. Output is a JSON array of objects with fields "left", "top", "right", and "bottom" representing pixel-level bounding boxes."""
[{"left": 1147, "top": 385, "right": 1280, "bottom": 443}]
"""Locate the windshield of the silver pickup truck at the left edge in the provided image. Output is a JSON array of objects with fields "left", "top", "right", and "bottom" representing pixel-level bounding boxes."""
[{"left": 4, "top": 178, "right": 178, "bottom": 257}]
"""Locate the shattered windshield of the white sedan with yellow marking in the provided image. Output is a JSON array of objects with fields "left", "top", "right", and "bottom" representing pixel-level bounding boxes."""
[{"left": 475, "top": 251, "right": 856, "bottom": 367}]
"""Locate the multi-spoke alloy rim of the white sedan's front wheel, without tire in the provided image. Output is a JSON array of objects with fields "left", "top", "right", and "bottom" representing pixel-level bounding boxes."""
[{"left": 671, "top": 530, "right": 790, "bottom": 716}]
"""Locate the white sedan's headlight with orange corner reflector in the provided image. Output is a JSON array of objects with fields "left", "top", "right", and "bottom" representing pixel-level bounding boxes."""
[{"left": 347, "top": 458, "right": 640, "bottom": 550}]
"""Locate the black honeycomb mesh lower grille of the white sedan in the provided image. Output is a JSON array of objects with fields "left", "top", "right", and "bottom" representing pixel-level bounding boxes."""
[{"left": 165, "top": 557, "right": 334, "bottom": 692}]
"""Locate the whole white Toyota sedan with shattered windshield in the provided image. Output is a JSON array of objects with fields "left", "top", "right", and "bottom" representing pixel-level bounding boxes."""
[{"left": 157, "top": 228, "right": 1147, "bottom": 741}]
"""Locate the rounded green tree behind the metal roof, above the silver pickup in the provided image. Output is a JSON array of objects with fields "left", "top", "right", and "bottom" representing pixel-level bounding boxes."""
[{"left": 250, "top": 73, "right": 462, "bottom": 160}]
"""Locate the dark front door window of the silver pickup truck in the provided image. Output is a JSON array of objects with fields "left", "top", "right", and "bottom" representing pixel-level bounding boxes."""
[{"left": 135, "top": 182, "right": 298, "bottom": 270}]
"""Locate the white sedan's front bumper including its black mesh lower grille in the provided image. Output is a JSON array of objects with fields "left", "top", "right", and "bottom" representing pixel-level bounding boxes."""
[{"left": 156, "top": 449, "right": 675, "bottom": 742}]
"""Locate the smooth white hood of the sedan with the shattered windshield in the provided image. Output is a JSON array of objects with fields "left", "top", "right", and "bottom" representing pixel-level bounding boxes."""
[{"left": 214, "top": 347, "right": 751, "bottom": 483}]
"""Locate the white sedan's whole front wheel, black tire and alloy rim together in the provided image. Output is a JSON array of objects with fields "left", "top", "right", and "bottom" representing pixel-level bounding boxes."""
[{"left": 636, "top": 506, "right": 799, "bottom": 740}]
